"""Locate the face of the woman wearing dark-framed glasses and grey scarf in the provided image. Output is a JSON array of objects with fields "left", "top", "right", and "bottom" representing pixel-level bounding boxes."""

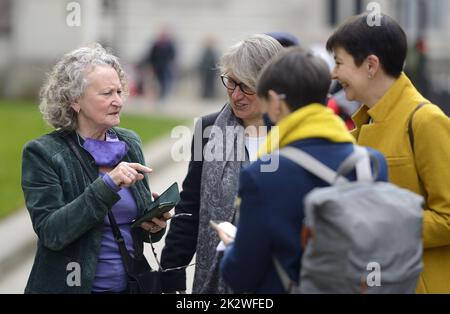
[{"left": 227, "top": 74, "right": 263, "bottom": 125}]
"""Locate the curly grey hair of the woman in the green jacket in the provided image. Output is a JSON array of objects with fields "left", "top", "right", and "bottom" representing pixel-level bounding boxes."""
[{"left": 39, "top": 44, "right": 128, "bottom": 130}]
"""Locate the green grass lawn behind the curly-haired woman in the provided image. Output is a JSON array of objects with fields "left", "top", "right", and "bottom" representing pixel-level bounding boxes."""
[{"left": 0, "top": 101, "right": 185, "bottom": 218}]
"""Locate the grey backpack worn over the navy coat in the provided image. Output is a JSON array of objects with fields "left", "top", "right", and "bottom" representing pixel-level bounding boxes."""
[{"left": 273, "top": 145, "right": 423, "bottom": 293}]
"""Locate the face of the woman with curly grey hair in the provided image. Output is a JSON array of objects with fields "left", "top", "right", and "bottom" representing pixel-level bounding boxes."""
[{"left": 72, "top": 66, "right": 123, "bottom": 136}]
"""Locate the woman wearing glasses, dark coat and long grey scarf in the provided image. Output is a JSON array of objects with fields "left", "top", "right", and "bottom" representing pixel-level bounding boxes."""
[{"left": 161, "top": 35, "right": 283, "bottom": 293}]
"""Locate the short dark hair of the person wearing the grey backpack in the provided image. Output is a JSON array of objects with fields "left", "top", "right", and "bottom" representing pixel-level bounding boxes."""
[{"left": 256, "top": 47, "right": 331, "bottom": 111}]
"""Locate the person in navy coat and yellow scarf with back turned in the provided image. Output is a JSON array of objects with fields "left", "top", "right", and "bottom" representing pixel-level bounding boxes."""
[{"left": 214, "top": 47, "right": 387, "bottom": 293}]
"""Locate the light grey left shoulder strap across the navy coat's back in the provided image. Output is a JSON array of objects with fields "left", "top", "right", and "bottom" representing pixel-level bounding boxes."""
[{"left": 280, "top": 146, "right": 348, "bottom": 184}]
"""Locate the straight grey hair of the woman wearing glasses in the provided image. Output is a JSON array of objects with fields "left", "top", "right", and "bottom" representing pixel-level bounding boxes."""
[{"left": 219, "top": 34, "right": 283, "bottom": 90}]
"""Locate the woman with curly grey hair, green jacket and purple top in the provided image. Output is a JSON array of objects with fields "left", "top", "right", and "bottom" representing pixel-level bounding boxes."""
[{"left": 22, "top": 44, "right": 170, "bottom": 293}]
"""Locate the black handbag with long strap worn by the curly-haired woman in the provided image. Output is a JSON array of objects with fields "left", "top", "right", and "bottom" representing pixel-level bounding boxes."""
[{"left": 64, "top": 134, "right": 162, "bottom": 294}]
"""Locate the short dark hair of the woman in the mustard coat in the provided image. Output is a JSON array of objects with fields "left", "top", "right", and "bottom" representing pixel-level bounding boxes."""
[{"left": 326, "top": 13, "right": 407, "bottom": 78}]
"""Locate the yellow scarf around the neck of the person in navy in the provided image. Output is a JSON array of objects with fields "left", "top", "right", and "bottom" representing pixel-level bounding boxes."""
[{"left": 259, "top": 103, "right": 355, "bottom": 156}]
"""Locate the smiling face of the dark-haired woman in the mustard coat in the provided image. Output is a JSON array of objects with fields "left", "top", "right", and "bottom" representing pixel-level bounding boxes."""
[{"left": 333, "top": 47, "right": 370, "bottom": 103}]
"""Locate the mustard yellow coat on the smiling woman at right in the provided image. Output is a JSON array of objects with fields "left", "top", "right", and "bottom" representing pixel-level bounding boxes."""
[{"left": 352, "top": 73, "right": 450, "bottom": 293}]
